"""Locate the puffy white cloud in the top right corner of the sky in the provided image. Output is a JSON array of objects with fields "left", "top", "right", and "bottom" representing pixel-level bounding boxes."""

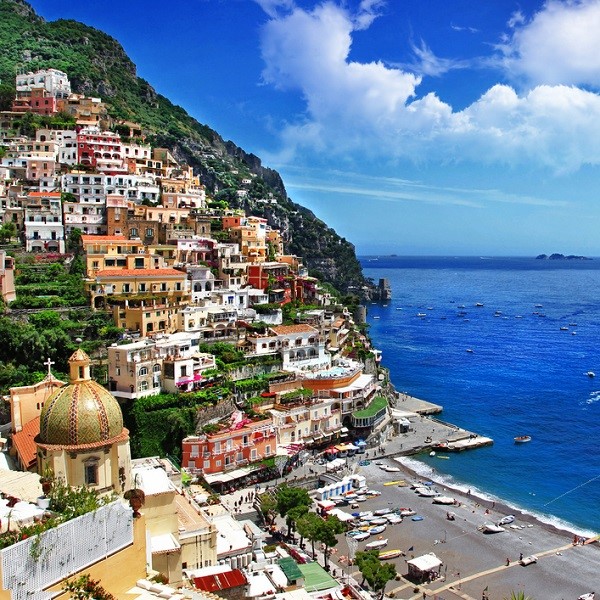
[{"left": 502, "top": 0, "right": 600, "bottom": 89}]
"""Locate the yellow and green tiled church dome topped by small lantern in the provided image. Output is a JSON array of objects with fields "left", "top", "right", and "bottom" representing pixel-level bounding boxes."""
[{"left": 39, "top": 350, "right": 126, "bottom": 446}]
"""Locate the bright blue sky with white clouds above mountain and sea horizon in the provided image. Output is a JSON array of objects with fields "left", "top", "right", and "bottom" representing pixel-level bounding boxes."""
[{"left": 30, "top": 0, "right": 600, "bottom": 256}]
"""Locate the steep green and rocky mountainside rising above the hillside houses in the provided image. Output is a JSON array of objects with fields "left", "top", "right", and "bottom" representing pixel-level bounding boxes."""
[{"left": 0, "top": 0, "right": 369, "bottom": 295}]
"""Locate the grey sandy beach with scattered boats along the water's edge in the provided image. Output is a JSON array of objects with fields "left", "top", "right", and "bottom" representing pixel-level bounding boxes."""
[{"left": 337, "top": 458, "right": 600, "bottom": 600}]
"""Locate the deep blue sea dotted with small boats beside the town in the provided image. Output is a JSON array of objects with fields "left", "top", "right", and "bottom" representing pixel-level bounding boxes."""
[{"left": 361, "top": 256, "right": 600, "bottom": 534}]
